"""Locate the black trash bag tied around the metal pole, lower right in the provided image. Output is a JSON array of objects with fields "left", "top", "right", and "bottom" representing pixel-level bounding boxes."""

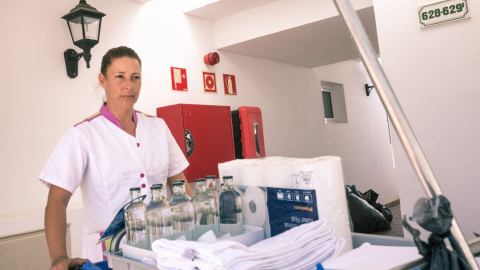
[{"left": 403, "top": 195, "right": 471, "bottom": 270}]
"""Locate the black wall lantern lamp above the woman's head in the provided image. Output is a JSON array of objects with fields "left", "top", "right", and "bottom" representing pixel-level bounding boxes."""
[{"left": 62, "top": 0, "right": 105, "bottom": 78}]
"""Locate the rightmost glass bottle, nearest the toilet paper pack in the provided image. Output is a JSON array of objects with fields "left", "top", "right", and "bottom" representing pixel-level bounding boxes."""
[{"left": 219, "top": 175, "right": 243, "bottom": 235}]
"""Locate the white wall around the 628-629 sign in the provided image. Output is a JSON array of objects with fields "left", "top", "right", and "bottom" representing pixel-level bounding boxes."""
[{"left": 374, "top": 0, "right": 480, "bottom": 239}]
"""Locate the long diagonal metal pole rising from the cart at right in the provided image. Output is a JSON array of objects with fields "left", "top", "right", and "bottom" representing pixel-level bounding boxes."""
[{"left": 333, "top": 0, "right": 479, "bottom": 270}]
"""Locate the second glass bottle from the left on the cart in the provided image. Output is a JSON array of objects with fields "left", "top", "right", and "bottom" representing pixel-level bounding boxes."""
[{"left": 145, "top": 184, "right": 173, "bottom": 247}]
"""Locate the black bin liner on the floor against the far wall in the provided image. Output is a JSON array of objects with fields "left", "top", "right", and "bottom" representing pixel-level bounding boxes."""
[{"left": 345, "top": 185, "right": 393, "bottom": 233}]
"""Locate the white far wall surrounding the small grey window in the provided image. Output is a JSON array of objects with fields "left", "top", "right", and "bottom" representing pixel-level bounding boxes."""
[{"left": 314, "top": 61, "right": 398, "bottom": 203}]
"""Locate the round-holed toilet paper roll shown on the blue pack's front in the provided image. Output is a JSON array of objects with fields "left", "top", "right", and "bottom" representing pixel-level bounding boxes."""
[{"left": 242, "top": 187, "right": 267, "bottom": 227}]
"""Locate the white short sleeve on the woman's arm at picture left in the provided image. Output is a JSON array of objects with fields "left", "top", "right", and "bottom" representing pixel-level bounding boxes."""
[{"left": 39, "top": 127, "right": 88, "bottom": 194}]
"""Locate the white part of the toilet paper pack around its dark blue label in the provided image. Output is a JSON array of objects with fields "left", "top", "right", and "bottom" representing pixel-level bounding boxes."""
[{"left": 218, "top": 156, "right": 353, "bottom": 253}]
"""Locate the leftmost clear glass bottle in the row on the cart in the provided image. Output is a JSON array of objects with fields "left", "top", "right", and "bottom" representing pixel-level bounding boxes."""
[{"left": 125, "top": 187, "right": 147, "bottom": 248}]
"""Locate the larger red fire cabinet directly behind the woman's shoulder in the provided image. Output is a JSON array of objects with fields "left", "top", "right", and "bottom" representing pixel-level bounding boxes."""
[{"left": 157, "top": 104, "right": 235, "bottom": 182}]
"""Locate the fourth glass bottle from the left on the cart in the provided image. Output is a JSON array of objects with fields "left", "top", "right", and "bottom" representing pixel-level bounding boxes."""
[{"left": 192, "top": 178, "right": 215, "bottom": 240}]
